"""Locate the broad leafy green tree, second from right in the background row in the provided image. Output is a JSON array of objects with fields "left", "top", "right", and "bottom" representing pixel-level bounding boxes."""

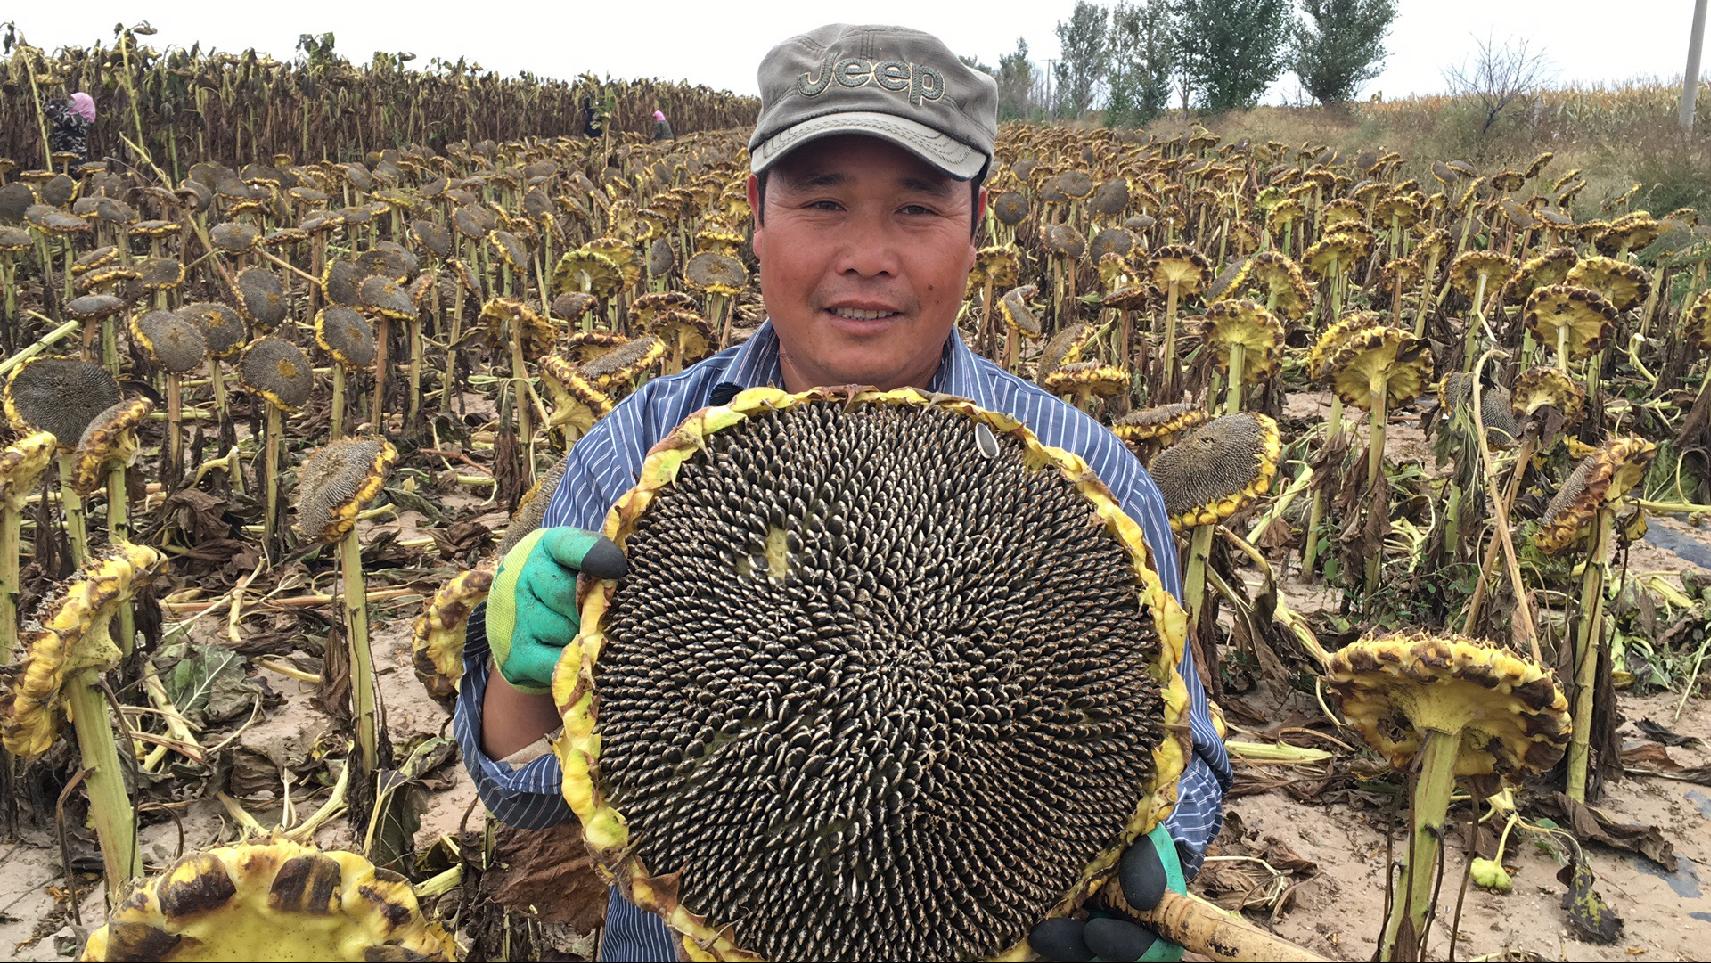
[{"left": 1170, "top": 0, "right": 1290, "bottom": 113}]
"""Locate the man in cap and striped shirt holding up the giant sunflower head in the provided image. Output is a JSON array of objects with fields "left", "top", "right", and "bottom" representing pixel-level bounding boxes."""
[{"left": 457, "top": 24, "right": 1230, "bottom": 960}]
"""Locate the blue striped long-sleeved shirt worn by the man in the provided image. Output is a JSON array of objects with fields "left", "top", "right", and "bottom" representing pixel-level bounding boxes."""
[{"left": 455, "top": 322, "right": 1230, "bottom": 960}]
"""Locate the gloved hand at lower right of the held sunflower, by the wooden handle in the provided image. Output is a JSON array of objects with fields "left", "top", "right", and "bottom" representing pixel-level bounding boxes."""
[{"left": 1028, "top": 826, "right": 1187, "bottom": 961}]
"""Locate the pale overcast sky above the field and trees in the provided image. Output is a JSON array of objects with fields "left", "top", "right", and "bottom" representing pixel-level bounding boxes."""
[{"left": 0, "top": 0, "right": 1711, "bottom": 101}]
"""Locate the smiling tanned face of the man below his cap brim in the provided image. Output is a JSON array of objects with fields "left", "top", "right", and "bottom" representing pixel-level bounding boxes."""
[{"left": 749, "top": 135, "right": 975, "bottom": 392}]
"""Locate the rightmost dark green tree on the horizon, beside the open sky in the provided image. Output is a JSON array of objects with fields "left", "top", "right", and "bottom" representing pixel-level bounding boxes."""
[{"left": 1292, "top": 0, "right": 1396, "bottom": 104}]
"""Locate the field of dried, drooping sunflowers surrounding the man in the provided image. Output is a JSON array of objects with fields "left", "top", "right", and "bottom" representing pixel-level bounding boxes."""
[{"left": 0, "top": 45, "right": 1711, "bottom": 960}]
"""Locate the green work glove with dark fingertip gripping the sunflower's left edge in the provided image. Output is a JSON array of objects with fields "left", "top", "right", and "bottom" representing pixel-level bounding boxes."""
[{"left": 488, "top": 529, "right": 628, "bottom": 693}]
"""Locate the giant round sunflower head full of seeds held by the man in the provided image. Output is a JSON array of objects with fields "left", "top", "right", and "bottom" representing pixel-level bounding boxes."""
[{"left": 553, "top": 388, "right": 1184, "bottom": 960}]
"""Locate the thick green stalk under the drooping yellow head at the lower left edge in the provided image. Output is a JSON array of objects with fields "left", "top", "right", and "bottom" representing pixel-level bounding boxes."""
[{"left": 65, "top": 663, "right": 142, "bottom": 907}]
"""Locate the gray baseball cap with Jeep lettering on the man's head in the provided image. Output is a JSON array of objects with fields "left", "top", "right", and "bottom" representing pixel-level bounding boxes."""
[{"left": 749, "top": 24, "right": 998, "bottom": 180}]
